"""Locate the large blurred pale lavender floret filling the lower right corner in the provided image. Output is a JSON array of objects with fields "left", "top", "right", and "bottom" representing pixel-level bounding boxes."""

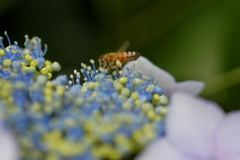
[{"left": 137, "top": 93, "right": 240, "bottom": 160}]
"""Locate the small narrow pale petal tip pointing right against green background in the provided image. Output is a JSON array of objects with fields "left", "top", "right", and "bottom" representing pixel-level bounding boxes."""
[{"left": 175, "top": 81, "right": 205, "bottom": 95}]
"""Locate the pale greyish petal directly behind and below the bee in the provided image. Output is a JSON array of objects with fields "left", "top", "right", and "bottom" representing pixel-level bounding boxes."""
[{"left": 123, "top": 56, "right": 175, "bottom": 98}]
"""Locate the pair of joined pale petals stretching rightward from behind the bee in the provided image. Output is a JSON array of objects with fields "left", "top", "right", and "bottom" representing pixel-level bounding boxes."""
[{"left": 123, "top": 56, "right": 205, "bottom": 98}]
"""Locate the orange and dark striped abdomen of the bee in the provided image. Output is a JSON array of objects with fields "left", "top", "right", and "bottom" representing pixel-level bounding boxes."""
[{"left": 117, "top": 51, "right": 141, "bottom": 63}]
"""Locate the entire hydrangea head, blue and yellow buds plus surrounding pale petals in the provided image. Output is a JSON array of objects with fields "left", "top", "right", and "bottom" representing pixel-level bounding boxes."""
[{"left": 0, "top": 32, "right": 214, "bottom": 160}]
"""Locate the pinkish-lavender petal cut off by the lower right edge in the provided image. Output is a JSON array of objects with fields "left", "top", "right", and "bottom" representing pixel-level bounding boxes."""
[{"left": 214, "top": 111, "right": 240, "bottom": 160}]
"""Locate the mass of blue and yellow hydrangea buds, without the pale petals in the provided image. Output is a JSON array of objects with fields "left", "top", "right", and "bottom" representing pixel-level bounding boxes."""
[{"left": 0, "top": 32, "right": 169, "bottom": 160}]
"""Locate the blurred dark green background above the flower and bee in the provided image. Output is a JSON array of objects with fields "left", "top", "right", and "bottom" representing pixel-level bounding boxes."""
[{"left": 0, "top": 0, "right": 240, "bottom": 111}]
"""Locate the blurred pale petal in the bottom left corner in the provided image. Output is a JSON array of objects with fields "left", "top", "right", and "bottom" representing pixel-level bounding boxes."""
[{"left": 0, "top": 122, "right": 19, "bottom": 160}]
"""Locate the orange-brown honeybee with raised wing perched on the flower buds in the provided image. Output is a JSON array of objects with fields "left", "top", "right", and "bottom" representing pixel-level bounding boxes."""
[{"left": 98, "top": 41, "right": 141, "bottom": 72}]
